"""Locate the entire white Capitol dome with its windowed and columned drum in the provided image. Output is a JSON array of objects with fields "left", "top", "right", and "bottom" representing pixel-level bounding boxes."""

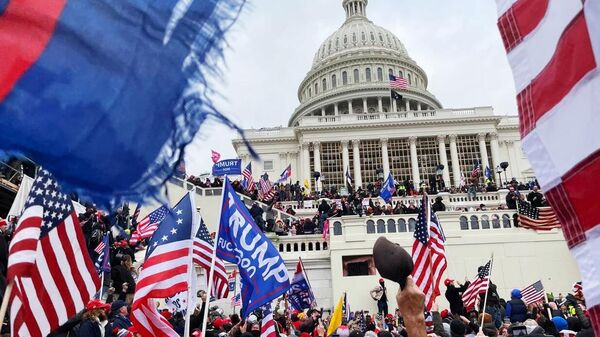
[{"left": 289, "top": 0, "right": 442, "bottom": 126}]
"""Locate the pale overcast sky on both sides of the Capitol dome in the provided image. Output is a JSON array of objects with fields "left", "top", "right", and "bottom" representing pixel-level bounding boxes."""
[{"left": 186, "top": 0, "right": 517, "bottom": 175}]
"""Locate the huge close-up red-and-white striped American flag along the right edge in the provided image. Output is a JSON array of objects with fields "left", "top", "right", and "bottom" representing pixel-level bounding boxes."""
[{"left": 496, "top": 0, "right": 600, "bottom": 335}]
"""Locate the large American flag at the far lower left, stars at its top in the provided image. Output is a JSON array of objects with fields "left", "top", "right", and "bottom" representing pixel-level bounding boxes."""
[{"left": 7, "top": 170, "right": 100, "bottom": 336}]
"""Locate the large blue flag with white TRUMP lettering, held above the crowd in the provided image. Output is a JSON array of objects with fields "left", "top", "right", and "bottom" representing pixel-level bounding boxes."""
[{"left": 216, "top": 179, "right": 290, "bottom": 317}]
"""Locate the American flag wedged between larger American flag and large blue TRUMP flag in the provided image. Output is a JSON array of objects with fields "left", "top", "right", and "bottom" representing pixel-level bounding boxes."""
[{"left": 193, "top": 220, "right": 229, "bottom": 299}]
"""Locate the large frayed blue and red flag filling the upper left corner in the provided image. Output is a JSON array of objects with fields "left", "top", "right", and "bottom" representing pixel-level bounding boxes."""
[{"left": 0, "top": 0, "right": 254, "bottom": 203}]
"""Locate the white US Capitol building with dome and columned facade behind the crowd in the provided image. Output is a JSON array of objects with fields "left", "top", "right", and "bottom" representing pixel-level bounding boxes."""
[{"left": 163, "top": 0, "right": 580, "bottom": 312}]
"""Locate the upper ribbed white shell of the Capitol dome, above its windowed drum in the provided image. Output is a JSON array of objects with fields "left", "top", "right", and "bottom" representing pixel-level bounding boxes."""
[{"left": 312, "top": 16, "right": 409, "bottom": 69}]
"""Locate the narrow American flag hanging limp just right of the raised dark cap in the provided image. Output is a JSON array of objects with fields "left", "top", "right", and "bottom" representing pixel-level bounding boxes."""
[{"left": 412, "top": 196, "right": 446, "bottom": 310}]
